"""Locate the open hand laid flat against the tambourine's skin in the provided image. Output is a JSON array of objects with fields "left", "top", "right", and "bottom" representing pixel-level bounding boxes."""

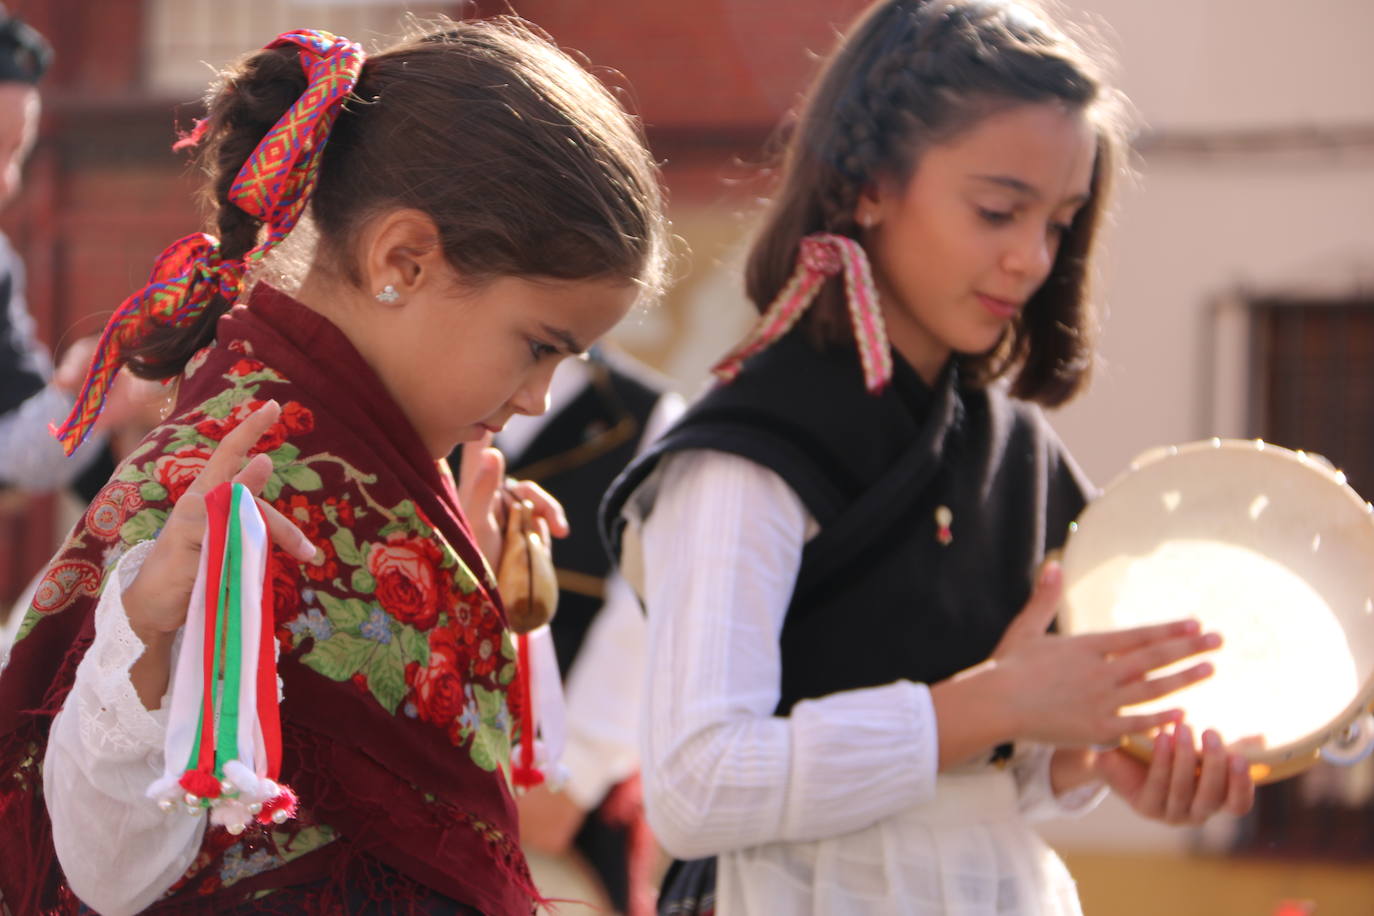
[{"left": 992, "top": 562, "right": 1221, "bottom": 746}]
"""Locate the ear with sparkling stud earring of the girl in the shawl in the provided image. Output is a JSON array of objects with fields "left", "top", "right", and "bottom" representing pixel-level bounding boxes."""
[{"left": 360, "top": 209, "right": 452, "bottom": 305}]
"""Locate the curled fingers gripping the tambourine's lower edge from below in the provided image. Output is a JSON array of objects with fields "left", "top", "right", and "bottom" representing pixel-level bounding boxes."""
[{"left": 1094, "top": 722, "right": 1254, "bottom": 824}]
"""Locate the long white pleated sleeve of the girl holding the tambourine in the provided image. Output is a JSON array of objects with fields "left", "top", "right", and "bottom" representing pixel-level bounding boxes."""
[{"left": 627, "top": 450, "right": 938, "bottom": 858}]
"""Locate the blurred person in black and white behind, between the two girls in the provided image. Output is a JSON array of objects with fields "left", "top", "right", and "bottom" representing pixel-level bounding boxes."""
[{"left": 449, "top": 346, "right": 683, "bottom": 916}]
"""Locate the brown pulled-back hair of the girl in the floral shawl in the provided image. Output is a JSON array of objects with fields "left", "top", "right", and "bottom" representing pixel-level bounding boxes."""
[{"left": 126, "top": 16, "right": 666, "bottom": 378}]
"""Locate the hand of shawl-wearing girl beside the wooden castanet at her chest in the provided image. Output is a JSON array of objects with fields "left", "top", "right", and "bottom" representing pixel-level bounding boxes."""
[{"left": 458, "top": 435, "right": 567, "bottom": 570}]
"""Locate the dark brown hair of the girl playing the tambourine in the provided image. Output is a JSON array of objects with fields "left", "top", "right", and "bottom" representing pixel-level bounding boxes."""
[{"left": 746, "top": 0, "right": 1123, "bottom": 405}]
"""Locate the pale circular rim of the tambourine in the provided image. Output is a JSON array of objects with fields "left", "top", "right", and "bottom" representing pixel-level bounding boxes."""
[{"left": 1058, "top": 438, "right": 1374, "bottom": 781}]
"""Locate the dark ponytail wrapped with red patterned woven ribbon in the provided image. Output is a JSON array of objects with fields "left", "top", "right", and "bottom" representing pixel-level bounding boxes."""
[{"left": 54, "top": 32, "right": 363, "bottom": 455}]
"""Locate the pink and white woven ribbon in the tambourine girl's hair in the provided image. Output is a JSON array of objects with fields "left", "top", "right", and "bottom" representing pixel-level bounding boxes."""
[{"left": 712, "top": 232, "right": 892, "bottom": 394}]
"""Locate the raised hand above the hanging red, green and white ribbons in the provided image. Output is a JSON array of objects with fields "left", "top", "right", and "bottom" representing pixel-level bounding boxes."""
[{"left": 124, "top": 401, "right": 315, "bottom": 645}]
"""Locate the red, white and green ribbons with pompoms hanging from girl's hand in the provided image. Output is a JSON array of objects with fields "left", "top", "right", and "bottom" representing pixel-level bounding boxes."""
[{"left": 147, "top": 483, "right": 295, "bottom": 834}]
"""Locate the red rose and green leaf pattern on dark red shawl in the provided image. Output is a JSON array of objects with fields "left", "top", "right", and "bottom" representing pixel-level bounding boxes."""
[{"left": 3, "top": 295, "right": 528, "bottom": 916}]
